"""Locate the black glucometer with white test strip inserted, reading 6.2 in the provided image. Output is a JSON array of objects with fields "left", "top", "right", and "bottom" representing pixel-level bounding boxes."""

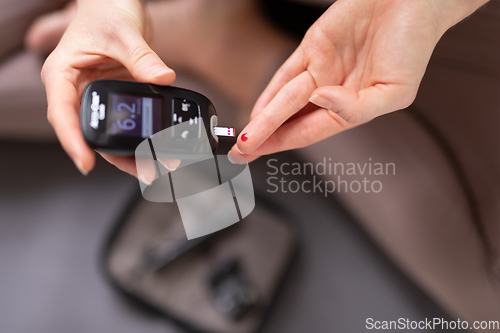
[{"left": 80, "top": 80, "right": 234, "bottom": 155}]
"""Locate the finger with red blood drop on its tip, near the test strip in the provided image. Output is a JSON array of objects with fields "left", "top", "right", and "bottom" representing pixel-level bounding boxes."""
[{"left": 236, "top": 71, "right": 316, "bottom": 154}]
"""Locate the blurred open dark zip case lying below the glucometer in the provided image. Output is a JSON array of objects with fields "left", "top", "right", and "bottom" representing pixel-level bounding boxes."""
[{"left": 102, "top": 195, "right": 298, "bottom": 333}]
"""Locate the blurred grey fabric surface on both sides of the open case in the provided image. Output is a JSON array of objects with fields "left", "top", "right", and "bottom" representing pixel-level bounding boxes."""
[{"left": 0, "top": 142, "right": 454, "bottom": 333}]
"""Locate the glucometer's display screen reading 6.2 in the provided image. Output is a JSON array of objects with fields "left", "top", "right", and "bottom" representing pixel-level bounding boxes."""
[{"left": 106, "top": 93, "right": 162, "bottom": 138}]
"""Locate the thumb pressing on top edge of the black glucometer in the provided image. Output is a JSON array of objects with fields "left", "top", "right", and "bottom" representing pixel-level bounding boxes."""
[{"left": 115, "top": 32, "right": 175, "bottom": 85}]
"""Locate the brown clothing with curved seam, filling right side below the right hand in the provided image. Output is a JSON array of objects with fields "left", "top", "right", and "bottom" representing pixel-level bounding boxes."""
[{"left": 303, "top": 1, "right": 500, "bottom": 330}]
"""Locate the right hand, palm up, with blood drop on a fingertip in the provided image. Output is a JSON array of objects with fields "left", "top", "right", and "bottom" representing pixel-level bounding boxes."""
[{"left": 230, "top": 0, "right": 487, "bottom": 161}]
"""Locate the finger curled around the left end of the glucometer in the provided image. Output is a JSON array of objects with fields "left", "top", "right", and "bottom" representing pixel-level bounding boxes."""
[{"left": 44, "top": 65, "right": 95, "bottom": 175}]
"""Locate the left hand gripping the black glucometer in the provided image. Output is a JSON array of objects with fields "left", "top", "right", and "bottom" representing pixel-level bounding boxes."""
[{"left": 42, "top": 0, "right": 175, "bottom": 176}]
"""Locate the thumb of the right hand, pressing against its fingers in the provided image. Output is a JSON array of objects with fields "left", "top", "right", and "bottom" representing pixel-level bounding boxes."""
[{"left": 310, "top": 84, "right": 416, "bottom": 124}]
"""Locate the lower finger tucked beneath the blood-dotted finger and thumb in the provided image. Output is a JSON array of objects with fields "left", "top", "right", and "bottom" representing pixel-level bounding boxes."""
[{"left": 230, "top": 109, "right": 354, "bottom": 157}]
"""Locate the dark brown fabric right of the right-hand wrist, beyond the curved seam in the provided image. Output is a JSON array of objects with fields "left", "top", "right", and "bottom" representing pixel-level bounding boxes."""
[{"left": 415, "top": 1, "right": 500, "bottom": 279}]
